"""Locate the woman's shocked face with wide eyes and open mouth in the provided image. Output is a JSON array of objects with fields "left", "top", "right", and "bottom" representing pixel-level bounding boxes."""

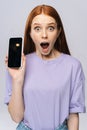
[{"left": 30, "top": 14, "right": 60, "bottom": 56}]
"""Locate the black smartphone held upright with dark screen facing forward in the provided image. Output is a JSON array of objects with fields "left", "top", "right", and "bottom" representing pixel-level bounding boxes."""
[{"left": 8, "top": 37, "right": 22, "bottom": 68}]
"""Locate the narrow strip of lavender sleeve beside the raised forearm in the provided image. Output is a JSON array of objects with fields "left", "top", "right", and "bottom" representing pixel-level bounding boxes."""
[{"left": 4, "top": 71, "right": 12, "bottom": 104}]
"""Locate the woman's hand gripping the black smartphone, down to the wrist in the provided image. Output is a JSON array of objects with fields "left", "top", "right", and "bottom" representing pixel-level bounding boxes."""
[{"left": 5, "top": 54, "right": 26, "bottom": 83}]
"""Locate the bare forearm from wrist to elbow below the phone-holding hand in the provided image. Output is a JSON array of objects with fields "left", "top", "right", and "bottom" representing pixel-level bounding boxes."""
[{"left": 8, "top": 81, "right": 24, "bottom": 123}]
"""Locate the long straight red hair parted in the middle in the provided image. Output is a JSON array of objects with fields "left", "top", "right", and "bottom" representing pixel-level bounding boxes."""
[{"left": 23, "top": 5, "right": 70, "bottom": 55}]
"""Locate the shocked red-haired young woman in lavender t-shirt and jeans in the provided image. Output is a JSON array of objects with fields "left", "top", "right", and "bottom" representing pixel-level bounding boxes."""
[{"left": 5, "top": 5, "right": 85, "bottom": 130}]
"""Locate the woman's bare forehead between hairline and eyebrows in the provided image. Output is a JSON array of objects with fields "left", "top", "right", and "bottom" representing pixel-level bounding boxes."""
[{"left": 32, "top": 14, "right": 56, "bottom": 24}]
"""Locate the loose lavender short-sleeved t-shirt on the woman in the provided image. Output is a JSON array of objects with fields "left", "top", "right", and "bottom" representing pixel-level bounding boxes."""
[{"left": 5, "top": 53, "right": 85, "bottom": 130}]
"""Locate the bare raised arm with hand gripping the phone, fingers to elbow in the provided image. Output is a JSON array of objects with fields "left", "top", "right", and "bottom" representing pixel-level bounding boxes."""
[{"left": 6, "top": 56, "right": 25, "bottom": 123}]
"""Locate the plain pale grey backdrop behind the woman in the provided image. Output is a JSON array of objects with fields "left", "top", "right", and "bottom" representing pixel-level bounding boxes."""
[{"left": 0, "top": 0, "right": 87, "bottom": 130}]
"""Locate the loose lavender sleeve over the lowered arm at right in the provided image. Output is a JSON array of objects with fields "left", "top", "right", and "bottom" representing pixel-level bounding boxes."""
[{"left": 69, "top": 62, "right": 86, "bottom": 113}]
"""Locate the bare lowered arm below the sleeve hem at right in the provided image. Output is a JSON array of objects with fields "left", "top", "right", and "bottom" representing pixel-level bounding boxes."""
[{"left": 67, "top": 113, "right": 79, "bottom": 130}]
